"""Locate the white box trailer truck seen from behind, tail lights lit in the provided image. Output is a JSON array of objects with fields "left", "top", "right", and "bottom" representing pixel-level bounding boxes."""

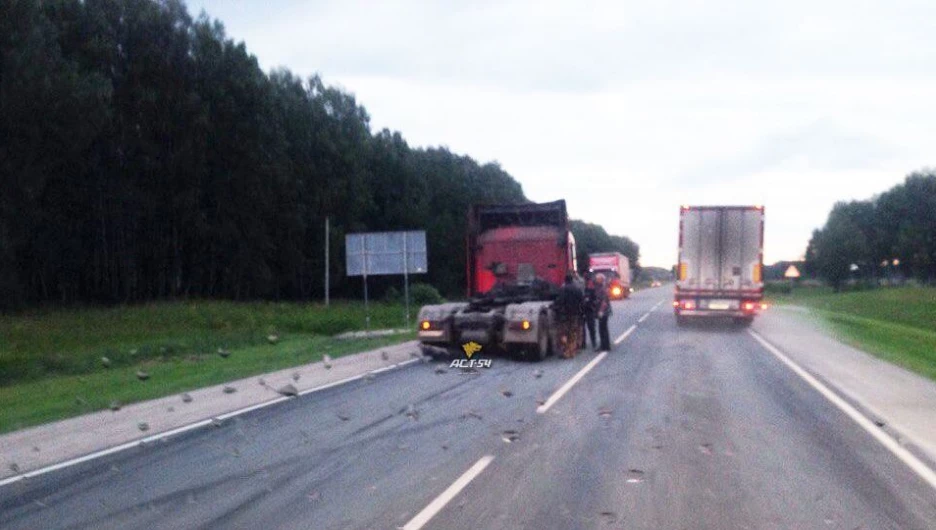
[{"left": 673, "top": 206, "right": 766, "bottom": 325}]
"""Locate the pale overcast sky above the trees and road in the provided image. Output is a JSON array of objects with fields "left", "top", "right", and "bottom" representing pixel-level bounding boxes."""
[{"left": 189, "top": 0, "right": 936, "bottom": 268}]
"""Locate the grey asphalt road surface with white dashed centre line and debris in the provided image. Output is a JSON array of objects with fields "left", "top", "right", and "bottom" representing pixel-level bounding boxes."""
[{"left": 0, "top": 289, "right": 936, "bottom": 530}]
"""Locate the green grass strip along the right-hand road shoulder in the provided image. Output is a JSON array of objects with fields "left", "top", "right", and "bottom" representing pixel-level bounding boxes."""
[{"left": 771, "top": 287, "right": 936, "bottom": 380}]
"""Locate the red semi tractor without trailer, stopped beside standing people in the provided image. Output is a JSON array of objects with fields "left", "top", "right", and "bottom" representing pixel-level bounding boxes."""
[{"left": 418, "top": 200, "right": 578, "bottom": 360}]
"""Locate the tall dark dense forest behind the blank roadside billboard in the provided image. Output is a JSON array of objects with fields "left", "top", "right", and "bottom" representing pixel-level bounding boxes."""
[{"left": 0, "top": 0, "right": 638, "bottom": 308}]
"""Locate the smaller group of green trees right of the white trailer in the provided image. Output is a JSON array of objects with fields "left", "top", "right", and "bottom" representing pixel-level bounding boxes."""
[{"left": 806, "top": 170, "right": 936, "bottom": 289}]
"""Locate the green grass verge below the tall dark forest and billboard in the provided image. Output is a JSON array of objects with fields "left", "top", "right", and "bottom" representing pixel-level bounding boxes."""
[{"left": 0, "top": 301, "right": 415, "bottom": 432}]
